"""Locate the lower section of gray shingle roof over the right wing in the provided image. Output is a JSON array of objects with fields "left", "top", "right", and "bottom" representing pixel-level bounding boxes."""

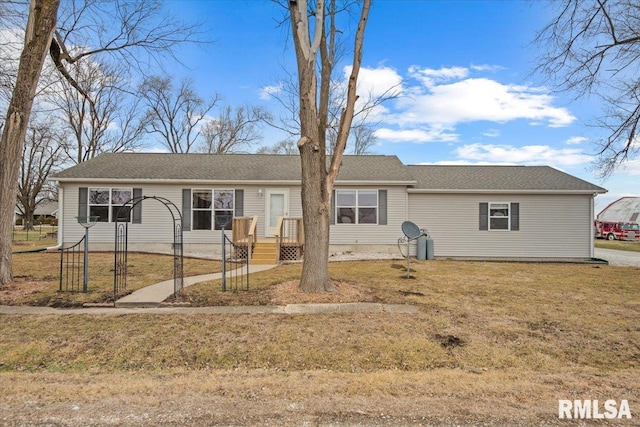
[{"left": 407, "top": 165, "right": 607, "bottom": 193}]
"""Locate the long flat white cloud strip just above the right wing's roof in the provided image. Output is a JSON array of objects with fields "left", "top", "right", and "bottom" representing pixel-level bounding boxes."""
[{"left": 455, "top": 144, "right": 593, "bottom": 166}]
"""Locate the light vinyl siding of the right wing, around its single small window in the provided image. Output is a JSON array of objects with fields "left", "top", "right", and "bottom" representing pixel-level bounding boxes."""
[{"left": 409, "top": 193, "right": 592, "bottom": 258}]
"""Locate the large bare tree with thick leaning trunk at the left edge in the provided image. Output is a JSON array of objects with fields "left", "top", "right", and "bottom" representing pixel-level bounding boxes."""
[{"left": 0, "top": 0, "right": 205, "bottom": 285}]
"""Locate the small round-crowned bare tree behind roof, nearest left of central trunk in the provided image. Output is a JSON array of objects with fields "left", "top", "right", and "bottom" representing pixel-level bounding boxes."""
[{"left": 200, "top": 105, "right": 271, "bottom": 154}]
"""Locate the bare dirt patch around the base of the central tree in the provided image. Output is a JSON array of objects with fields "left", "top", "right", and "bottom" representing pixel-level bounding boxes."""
[{"left": 268, "top": 280, "right": 375, "bottom": 305}]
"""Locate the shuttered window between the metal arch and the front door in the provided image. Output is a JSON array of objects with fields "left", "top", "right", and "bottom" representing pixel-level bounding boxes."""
[{"left": 191, "top": 190, "right": 234, "bottom": 230}]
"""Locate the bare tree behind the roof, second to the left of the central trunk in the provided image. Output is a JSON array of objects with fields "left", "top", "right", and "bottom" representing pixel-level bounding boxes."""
[{"left": 140, "top": 76, "right": 218, "bottom": 153}]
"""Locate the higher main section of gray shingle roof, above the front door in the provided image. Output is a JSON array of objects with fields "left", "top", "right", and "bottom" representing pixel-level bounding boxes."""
[{"left": 53, "top": 153, "right": 415, "bottom": 184}]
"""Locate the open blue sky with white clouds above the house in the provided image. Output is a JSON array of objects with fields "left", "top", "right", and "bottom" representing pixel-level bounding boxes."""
[{"left": 132, "top": 0, "right": 640, "bottom": 212}]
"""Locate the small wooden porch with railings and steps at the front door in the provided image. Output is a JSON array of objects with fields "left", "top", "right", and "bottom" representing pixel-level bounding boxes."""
[{"left": 232, "top": 215, "right": 304, "bottom": 264}]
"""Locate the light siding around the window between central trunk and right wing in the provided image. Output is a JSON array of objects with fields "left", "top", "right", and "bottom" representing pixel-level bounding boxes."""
[{"left": 329, "top": 186, "right": 407, "bottom": 245}]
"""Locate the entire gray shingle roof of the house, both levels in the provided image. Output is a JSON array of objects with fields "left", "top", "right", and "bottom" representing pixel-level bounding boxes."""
[{"left": 53, "top": 153, "right": 606, "bottom": 193}]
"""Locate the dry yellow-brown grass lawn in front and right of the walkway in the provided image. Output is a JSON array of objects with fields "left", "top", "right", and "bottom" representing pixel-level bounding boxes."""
[{"left": 0, "top": 260, "right": 640, "bottom": 426}]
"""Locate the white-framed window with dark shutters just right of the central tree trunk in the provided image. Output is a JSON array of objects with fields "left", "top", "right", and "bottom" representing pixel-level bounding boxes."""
[{"left": 336, "top": 190, "right": 378, "bottom": 224}]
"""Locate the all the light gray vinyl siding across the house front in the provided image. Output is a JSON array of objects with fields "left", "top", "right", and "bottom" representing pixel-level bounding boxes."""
[{"left": 62, "top": 182, "right": 592, "bottom": 258}]
